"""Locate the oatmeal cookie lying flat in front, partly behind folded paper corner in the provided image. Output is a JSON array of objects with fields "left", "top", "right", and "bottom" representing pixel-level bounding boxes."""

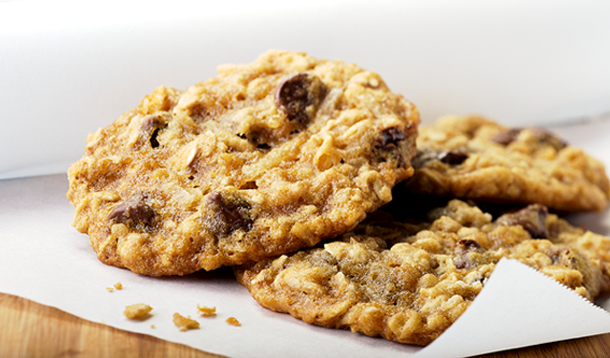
[{"left": 234, "top": 200, "right": 610, "bottom": 345}]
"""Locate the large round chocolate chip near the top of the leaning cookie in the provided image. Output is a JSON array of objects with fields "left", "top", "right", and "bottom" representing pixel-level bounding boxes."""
[{"left": 275, "top": 73, "right": 328, "bottom": 124}]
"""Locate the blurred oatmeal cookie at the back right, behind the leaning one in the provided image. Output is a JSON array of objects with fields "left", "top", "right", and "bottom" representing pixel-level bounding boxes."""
[{"left": 406, "top": 116, "right": 610, "bottom": 213}]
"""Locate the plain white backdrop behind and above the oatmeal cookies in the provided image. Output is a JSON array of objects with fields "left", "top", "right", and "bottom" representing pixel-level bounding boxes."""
[{"left": 0, "top": 0, "right": 610, "bottom": 179}]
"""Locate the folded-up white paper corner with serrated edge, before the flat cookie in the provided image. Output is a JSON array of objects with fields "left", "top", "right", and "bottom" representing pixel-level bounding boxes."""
[{"left": 414, "top": 258, "right": 610, "bottom": 358}]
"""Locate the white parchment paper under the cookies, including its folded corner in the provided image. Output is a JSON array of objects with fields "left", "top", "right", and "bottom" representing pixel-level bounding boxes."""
[{"left": 0, "top": 121, "right": 610, "bottom": 357}]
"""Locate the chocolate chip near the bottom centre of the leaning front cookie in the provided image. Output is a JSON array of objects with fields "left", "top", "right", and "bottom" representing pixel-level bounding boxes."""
[{"left": 207, "top": 192, "right": 253, "bottom": 235}]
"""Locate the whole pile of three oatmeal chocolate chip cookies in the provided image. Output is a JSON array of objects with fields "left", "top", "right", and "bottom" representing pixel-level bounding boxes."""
[{"left": 67, "top": 51, "right": 610, "bottom": 345}]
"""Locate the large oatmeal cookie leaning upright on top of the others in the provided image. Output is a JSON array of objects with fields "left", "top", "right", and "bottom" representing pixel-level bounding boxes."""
[{"left": 67, "top": 51, "right": 419, "bottom": 276}]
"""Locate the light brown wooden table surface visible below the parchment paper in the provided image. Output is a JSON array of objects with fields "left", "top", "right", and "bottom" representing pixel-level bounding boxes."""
[{"left": 0, "top": 293, "right": 610, "bottom": 358}]
